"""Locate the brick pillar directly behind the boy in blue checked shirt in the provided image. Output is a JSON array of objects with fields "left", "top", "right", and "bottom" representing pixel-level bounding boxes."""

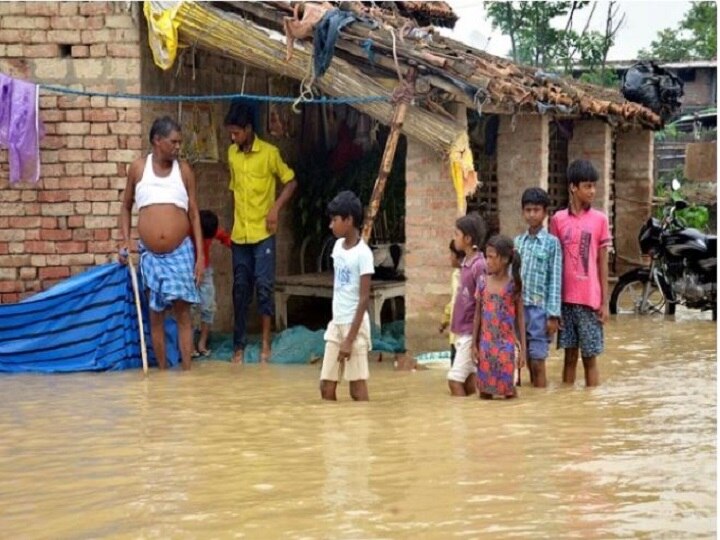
[{"left": 497, "top": 115, "right": 550, "bottom": 238}]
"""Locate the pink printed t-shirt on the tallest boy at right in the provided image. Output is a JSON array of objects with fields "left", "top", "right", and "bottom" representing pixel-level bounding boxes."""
[{"left": 550, "top": 208, "right": 612, "bottom": 310}]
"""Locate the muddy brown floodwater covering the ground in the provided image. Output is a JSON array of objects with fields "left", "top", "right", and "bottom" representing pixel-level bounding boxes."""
[{"left": 0, "top": 315, "right": 717, "bottom": 539}]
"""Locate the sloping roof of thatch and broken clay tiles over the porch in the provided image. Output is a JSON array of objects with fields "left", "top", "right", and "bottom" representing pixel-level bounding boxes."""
[{"left": 155, "top": 1, "right": 662, "bottom": 130}]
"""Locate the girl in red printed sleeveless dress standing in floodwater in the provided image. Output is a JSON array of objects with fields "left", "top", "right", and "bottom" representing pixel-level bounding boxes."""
[{"left": 473, "top": 235, "right": 525, "bottom": 399}]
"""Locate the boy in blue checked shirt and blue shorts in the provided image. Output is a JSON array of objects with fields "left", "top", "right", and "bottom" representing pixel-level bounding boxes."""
[{"left": 515, "top": 187, "right": 562, "bottom": 388}]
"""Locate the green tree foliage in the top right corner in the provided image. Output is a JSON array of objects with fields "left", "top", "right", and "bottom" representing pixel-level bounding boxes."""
[{"left": 638, "top": 2, "right": 717, "bottom": 62}]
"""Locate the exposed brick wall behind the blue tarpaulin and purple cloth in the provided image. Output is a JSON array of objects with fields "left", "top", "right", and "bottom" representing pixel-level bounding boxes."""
[{"left": 0, "top": 2, "right": 141, "bottom": 303}]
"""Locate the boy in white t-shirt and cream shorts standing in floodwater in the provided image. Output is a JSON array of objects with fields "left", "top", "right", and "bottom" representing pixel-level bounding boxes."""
[{"left": 320, "top": 191, "right": 375, "bottom": 401}]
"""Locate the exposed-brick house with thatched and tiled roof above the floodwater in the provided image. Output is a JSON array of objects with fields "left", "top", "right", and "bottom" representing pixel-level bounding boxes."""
[{"left": 0, "top": 2, "right": 660, "bottom": 350}]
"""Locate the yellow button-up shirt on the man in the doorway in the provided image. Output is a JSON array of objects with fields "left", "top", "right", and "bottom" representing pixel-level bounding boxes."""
[{"left": 228, "top": 135, "right": 295, "bottom": 244}]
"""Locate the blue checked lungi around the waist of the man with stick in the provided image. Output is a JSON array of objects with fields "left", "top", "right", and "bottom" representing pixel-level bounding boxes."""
[{"left": 139, "top": 237, "right": 200, "bottom": 311}]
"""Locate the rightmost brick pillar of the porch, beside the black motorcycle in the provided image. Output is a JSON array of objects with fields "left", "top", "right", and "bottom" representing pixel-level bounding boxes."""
[{"left": 615, "top": 129, "right": 655, "bottom": 274}]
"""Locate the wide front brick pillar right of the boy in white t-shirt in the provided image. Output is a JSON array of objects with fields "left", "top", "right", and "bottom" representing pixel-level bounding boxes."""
[{"left": 405, "top": 139, "right": 457, "bottom": 353}]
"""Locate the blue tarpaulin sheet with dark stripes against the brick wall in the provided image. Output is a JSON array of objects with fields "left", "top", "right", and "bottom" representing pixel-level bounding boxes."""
[{"left": 0, "top": 263, "right": 179, "bottom": 373}]
